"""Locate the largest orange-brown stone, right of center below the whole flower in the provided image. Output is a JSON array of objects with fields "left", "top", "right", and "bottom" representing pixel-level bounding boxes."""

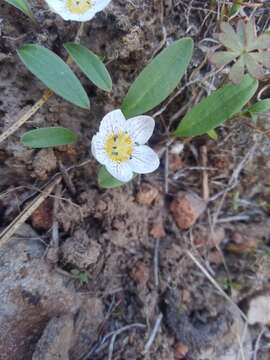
[{"left": 170, "top": 191, "right": 206, "bottom": 230}]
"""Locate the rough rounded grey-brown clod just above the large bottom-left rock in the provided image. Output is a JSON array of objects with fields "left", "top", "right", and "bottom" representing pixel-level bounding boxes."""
[{"left": 61, "top": 229, "right": 101, "bottom": 269}]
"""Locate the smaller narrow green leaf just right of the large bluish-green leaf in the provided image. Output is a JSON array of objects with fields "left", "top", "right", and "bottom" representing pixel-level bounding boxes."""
[{"left": 64, "top": 42, "right": 112, "bottom": 91}]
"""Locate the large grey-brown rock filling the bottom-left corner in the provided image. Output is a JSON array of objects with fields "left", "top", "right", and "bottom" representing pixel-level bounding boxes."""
[{"left": 0, "top": 224, "right": 81, "bottom": 360}]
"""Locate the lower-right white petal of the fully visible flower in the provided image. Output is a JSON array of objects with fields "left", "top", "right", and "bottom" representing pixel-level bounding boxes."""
[{"left": 128, "top": 145, "right": 160, "bottom": 174}]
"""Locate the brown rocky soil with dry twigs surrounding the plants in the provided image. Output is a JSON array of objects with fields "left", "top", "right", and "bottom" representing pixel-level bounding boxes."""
[{"left": 0, "top": 0, "right": 270, "bottom": 360}]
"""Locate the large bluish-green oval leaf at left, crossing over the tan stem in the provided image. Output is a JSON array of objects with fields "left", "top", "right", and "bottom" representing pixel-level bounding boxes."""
[{"left": 17, "top": 44, "right": 90, "bottom": 109}]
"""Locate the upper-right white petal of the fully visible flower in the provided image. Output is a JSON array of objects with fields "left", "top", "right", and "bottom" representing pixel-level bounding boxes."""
[{"left": 125, "top": 116, "right": 155, "bottom": 144}]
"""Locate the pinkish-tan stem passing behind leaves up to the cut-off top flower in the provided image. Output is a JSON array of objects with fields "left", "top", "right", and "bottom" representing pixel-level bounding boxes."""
[{"left": 0, "top": 23, "right": 83, "bottom": 144}]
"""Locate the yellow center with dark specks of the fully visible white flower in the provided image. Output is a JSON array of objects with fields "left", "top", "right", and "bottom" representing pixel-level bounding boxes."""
[{"left": 105, "top": 132, "right": 133, "bottom": 162}]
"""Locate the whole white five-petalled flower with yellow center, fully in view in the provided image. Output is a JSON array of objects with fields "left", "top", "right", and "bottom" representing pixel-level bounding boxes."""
[{"left": 91, "top": 110, "right": 159, "bottom": 182}]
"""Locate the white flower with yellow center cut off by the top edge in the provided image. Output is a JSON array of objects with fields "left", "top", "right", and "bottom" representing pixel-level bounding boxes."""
[{"left": 46, "top": 0, "right": 111, "bottom": 21}]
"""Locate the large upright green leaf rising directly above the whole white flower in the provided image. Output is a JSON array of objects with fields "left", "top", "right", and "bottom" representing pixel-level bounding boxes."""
[{"left": 122, "top": 38, "right": 193, "bottom": 118}]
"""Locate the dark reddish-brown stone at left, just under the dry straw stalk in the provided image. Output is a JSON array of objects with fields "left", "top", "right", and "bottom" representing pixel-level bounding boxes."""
[{"left": 31, "top": 199, "right": 53, "bottom": 231}]
